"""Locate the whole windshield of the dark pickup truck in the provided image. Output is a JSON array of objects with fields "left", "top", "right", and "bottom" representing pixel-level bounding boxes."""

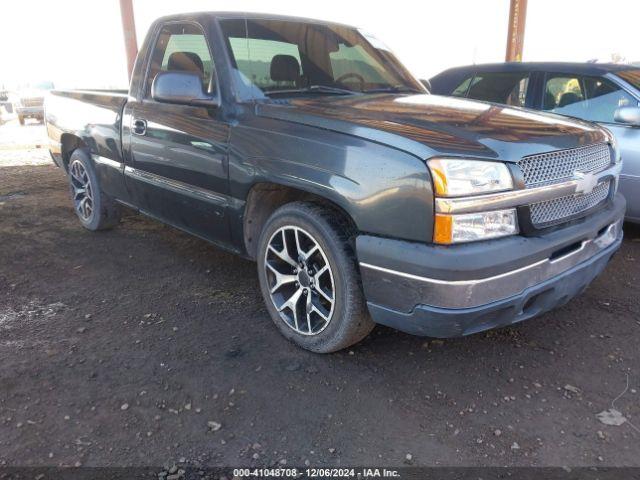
[{"left": 220, "top": 19, "right": 426, "bottom": 98}]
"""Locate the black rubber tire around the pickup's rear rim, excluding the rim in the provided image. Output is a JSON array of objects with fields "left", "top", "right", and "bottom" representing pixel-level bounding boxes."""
[{"left": 67, "top": 149, "right": 121, "bottom": 231}]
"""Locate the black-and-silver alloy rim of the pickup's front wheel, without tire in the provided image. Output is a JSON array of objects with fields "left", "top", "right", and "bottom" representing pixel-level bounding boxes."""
[{"left": 264, "top": 226, "right": 335, "bottom": 335}]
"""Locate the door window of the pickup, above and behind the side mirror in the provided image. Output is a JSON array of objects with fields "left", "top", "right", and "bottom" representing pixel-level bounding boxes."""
[{"left": 145, "top": 23, "right": 216, "bottom": 97}]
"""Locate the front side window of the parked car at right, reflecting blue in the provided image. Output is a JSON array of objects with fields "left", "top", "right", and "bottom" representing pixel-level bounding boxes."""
[{"left": 544, "top": 76, "right": 637, "bottom": 123}]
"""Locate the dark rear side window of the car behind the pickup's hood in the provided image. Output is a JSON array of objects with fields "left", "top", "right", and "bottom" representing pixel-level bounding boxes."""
[{"left": 467, "top": 72, "right": 530, "bottom": 107}]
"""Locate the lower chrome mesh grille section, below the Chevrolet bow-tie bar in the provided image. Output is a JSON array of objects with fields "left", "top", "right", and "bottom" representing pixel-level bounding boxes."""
[{"left": 530, "top": 181, "right": 611, "bottom": 227}]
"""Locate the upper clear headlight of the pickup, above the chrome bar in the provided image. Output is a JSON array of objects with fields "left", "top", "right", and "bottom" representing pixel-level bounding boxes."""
[{"left": 428, "top": 158, "right": 513, "bottom": 197}]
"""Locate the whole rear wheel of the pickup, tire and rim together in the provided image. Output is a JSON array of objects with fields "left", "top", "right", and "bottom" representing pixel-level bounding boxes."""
[{"left": 68, "top": 149, "right": 120, "bottom": 230}]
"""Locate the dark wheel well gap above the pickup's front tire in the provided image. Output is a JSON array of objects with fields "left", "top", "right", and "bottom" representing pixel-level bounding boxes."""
[{"left": 243, "top": 183, "right": 357, "bottom": 259}]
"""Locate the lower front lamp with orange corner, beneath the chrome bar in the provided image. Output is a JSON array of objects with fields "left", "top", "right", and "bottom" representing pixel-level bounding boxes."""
[{"left": 433, "top": 208, "right": 518, "bottom": 245}]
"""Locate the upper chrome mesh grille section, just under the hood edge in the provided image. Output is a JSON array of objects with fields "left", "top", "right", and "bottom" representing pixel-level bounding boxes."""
[{"left": 518, "top": 143, "right": 611, "bottom": 188}]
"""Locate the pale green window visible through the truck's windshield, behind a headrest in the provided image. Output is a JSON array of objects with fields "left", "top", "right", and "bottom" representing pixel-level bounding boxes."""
[{"left": 229, "top": 37, "right": 302, "bottom": 90}]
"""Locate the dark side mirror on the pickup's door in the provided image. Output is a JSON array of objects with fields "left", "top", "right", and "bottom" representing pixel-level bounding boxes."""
[{"left": 151, "top": 72, "right": 220, "bottom": 107}]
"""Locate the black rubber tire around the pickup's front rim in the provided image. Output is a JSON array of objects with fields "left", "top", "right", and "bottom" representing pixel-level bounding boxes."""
[{"left": 257, "top": 202, "right": 375, "bottom": 353}]
